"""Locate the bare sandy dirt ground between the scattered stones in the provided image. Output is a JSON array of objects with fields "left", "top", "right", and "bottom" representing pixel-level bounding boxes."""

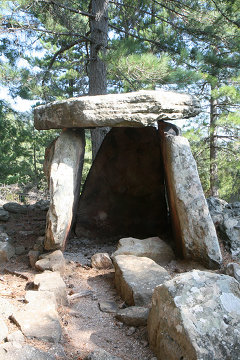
[{"left": 0, "top": 204, "right": 231, "bottom": 360}]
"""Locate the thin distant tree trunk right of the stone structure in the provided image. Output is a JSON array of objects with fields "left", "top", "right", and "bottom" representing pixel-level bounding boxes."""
[{"left": 209, "top": 89, "right": 219, "bottom": 197}]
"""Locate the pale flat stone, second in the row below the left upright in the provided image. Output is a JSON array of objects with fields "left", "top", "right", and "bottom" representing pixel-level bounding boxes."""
[{"left": 34, "top": 270, "right": 68, "bottom": 305}]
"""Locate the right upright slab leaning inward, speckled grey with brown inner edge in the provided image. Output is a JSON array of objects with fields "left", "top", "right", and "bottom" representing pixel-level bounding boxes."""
[{"left": 162, "top": 135, "right": 222, "bottom": 268}]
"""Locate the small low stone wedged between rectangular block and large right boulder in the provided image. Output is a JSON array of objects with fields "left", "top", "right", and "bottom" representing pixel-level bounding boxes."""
[{"left": 116, "top": 306, "right": 149, "bottom": 326}]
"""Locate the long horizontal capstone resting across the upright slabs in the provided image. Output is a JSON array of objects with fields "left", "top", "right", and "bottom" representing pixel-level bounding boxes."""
[{"left": 34, "top": 90, "right": 200, "bottom": 130}]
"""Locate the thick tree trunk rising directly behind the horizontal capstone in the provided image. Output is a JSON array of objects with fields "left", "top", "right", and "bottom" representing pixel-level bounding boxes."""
[{"left": 88, "top": 0, "right": 109, "bottom": 160}]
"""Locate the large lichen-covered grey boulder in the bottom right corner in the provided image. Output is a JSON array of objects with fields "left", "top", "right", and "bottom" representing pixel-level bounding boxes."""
[{"left": 148, "top": 270, "right": 240, "bottom": 360}]
